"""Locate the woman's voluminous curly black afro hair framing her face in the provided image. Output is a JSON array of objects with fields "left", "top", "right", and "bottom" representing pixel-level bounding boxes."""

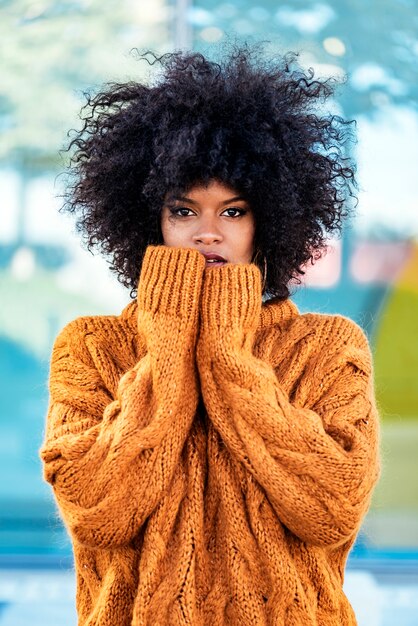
[{"left": 62, "top": 44, "right": 356, "bottom": 299}]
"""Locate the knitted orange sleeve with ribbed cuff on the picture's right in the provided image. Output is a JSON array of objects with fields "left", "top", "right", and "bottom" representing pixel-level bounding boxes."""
[{"left": 197, "top": 264, "right": 380, "bottom": 546}]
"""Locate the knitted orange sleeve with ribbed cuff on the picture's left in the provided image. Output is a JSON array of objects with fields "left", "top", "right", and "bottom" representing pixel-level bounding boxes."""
[{"left": 41, "top": 246, "right": 204, "bottom": 547}]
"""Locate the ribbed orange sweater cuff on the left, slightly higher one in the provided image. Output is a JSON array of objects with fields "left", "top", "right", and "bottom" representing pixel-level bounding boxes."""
[{"left": 137, "top": 245, "right": 205, "bottom": 317}]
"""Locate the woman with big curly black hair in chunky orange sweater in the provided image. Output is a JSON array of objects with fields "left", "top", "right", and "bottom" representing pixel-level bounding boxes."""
[{"left": 41, "top": 47, "right": 379, "bottom": 626}]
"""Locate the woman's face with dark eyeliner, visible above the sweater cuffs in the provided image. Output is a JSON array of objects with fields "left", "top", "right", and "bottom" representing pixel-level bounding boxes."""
[{"left": 161, "top": 180, "right": 255, "bottom": 267}]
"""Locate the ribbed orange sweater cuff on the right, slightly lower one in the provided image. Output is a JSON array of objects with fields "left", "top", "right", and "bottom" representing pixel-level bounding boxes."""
[{"left": 201, "top": 263, "right": 262, "bottom": 332}]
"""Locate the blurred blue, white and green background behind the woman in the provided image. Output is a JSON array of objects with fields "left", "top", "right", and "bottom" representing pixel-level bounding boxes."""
[{"left": 0, "top": 0, "right": 418, "bottom": 626}]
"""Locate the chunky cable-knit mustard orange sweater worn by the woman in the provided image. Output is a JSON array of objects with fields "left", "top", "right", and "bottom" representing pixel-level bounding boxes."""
[{"left": 41, "top": 246, "right": 380, "bottom": 626}]
